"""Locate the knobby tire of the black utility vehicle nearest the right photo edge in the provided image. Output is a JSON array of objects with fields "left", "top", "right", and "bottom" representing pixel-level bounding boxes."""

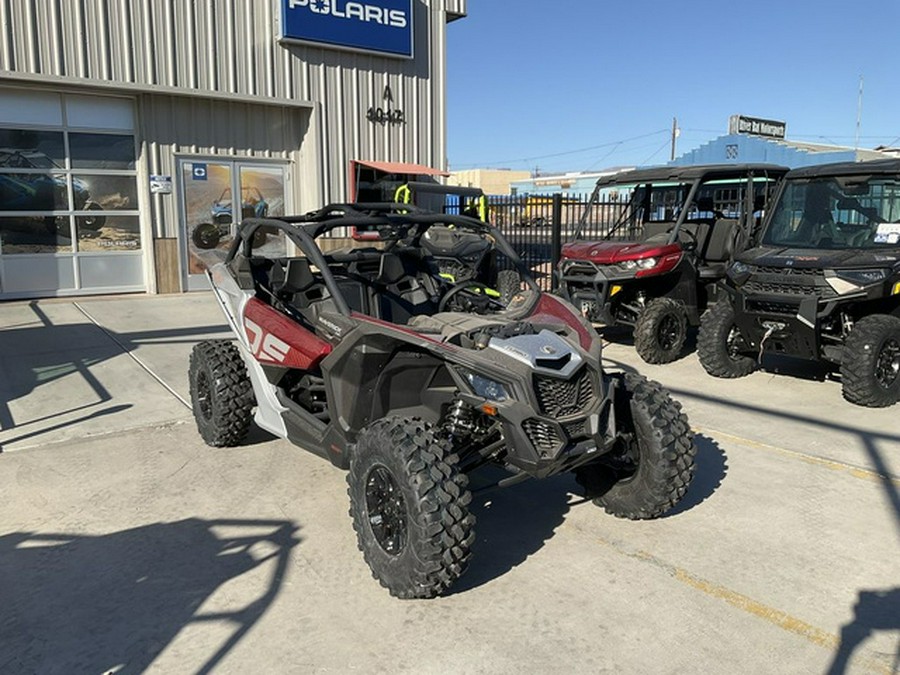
[{"left": 841, "top": 314, "right": 900, "bottom": 408}]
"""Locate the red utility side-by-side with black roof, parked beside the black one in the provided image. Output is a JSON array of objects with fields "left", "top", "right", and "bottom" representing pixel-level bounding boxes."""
[{"left": 559, "top": 164, "right": 787, "bottom": 363}]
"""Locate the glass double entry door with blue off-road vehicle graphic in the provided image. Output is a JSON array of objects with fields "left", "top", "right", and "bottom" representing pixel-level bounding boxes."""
[{"left": 179, "top": 159, "right": 287, "bottom": 291}]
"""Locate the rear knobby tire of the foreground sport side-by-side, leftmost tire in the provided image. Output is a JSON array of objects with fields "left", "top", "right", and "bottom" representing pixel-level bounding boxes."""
[{"left": 188, "top": 340, "right": 255, "bottom": 447}]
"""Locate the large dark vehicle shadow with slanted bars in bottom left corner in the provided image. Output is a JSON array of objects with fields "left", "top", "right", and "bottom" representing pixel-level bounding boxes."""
[{"left": 0, "top": 518, "right": 300, "bottom": 674}]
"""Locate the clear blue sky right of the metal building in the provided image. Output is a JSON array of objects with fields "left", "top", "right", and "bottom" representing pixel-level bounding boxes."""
[{"left": 447, "top": 0, "right": 900, "bottom": 174}]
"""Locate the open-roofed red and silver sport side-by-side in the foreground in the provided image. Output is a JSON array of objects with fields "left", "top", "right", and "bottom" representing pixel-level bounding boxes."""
[{"left": 190, "top": 204, "right": 695, "bottom": 598}]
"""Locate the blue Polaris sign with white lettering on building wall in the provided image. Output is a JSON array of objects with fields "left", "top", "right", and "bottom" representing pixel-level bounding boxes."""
[{"left": 281, "top": 0, "right": 413, "bottom": 57}]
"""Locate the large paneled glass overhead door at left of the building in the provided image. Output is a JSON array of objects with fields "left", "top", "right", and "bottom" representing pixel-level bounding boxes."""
[{"left": 0, "top": 86, "right": 145, "bottom": 298}]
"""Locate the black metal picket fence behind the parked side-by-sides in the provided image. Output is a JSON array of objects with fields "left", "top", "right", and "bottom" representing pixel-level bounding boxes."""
[{"left": 447, "top": 194, "right": 634, "bottom": 290}]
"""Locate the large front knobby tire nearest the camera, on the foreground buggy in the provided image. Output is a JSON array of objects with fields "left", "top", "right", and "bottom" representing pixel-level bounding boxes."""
[{"left": 347, "top": 417, "right": 475, "bottom": 598}]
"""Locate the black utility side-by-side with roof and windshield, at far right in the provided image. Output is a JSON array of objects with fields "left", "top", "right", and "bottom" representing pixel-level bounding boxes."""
[{"left": 698, "top": 159, "right": 900, "bottom": 407}]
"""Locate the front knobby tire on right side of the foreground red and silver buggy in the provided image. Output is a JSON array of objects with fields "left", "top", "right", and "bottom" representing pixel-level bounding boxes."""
[{"left": 575, "top": 373, "right": 697, "bottom": 520}]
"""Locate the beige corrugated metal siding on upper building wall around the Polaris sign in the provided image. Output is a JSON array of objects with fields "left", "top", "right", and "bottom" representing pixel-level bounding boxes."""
[{"left": 0, "top": 0, "right": 466, "bottom": 206}]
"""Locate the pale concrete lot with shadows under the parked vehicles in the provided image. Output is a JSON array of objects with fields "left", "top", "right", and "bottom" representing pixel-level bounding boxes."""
[{"left": 0, "top": 294, "right": 900, "bottom": 673}]
